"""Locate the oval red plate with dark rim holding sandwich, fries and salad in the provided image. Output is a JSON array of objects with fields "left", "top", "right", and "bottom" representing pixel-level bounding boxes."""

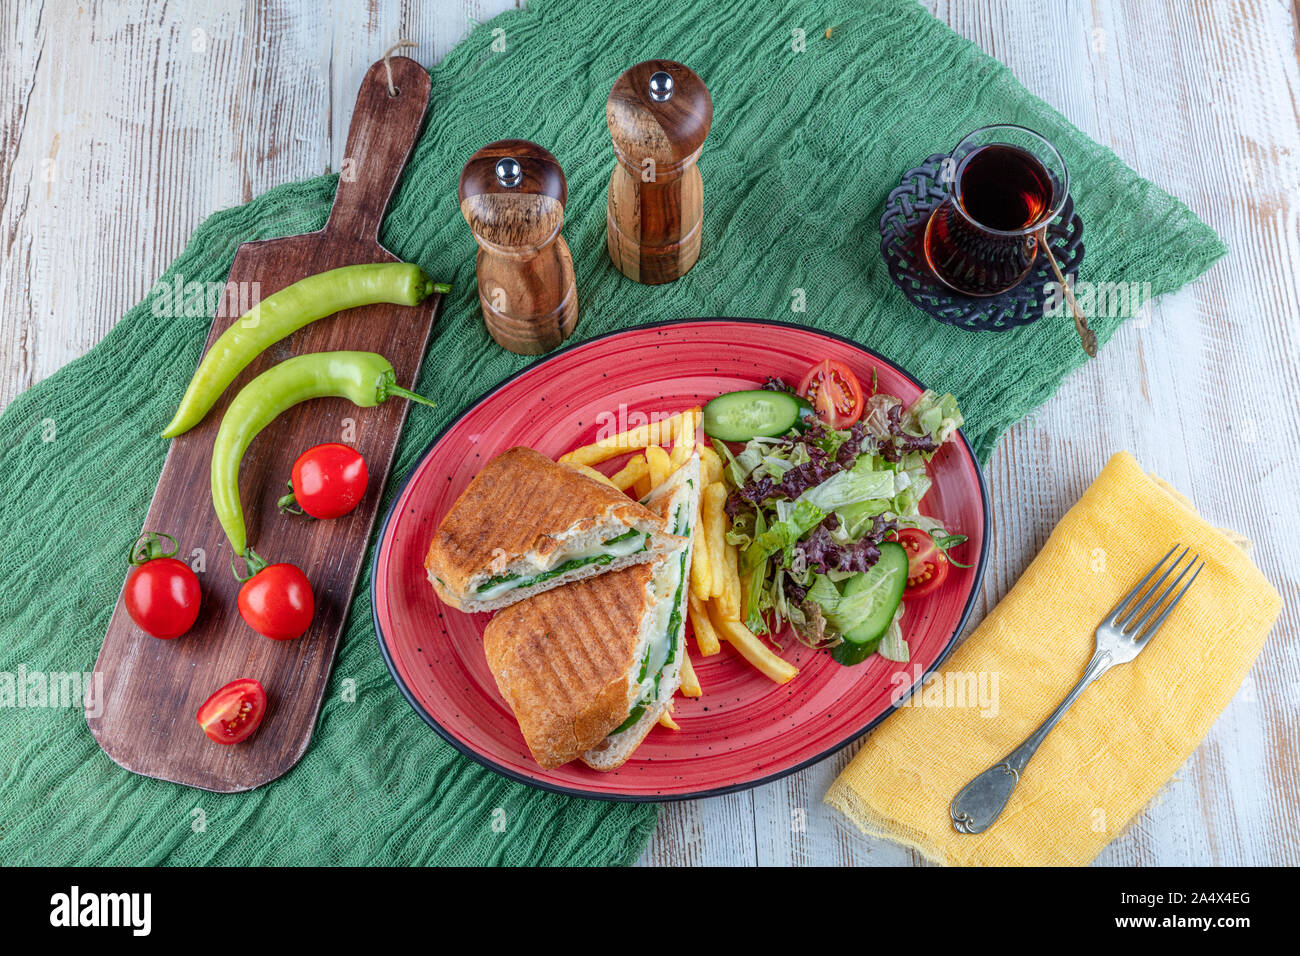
[{"left": 371, "top": 319, "right": 988, "bottom": 800}]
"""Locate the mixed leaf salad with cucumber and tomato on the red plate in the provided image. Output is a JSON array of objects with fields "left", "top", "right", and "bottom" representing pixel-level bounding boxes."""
[{"left": 705, "top": 378, "right": 966, "bottom": 665}]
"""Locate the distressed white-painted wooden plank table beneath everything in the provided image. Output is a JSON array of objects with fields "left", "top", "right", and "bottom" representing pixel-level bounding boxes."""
[{"left": 0, "top": 0, "right": 1300, "bottom": 866}]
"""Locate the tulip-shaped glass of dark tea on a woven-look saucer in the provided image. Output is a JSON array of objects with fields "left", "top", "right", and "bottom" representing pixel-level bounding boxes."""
[{"left": 924, "top": 124, "right": 1070, "bottom": 295}]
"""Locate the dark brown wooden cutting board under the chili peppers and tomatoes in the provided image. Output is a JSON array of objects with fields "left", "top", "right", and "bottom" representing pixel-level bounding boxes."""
[{"left": 86, "top": 56, "right": 441, "bottom": 792}]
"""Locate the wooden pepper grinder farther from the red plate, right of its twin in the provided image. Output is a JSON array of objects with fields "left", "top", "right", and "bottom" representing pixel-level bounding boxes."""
[{"left": 605, "top": 60, "right": 714, "bottom": 285}]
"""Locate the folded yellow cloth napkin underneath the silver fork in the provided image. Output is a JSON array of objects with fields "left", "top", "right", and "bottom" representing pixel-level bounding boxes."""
[{"left": 826, "top": 453, "right": 1282, "bottom": 865}]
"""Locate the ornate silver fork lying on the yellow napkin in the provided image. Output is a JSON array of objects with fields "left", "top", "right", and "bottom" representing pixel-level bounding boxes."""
[{"left": 948, "top": 545, "right": 1205, "bottom": 834}]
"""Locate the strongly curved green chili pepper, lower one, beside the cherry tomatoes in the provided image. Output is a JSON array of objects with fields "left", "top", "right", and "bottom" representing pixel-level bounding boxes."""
[{"left": 212, "top": 352, "right": 433, "bottom": 555}]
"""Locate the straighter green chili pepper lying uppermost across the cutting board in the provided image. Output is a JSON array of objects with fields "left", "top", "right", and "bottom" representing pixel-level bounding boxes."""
[{"left": 163, "top": 263, "right": 451, "bottom": 438}]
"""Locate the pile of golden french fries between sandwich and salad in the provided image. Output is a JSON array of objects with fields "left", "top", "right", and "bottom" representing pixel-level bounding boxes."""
[{"left": 559, "top": 408, "right": 798, "bottom": 730}]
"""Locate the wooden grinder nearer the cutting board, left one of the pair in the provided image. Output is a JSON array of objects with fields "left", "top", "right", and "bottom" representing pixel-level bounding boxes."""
[{"left": 459, "top": 139, "right": 577, "bottom": 355}]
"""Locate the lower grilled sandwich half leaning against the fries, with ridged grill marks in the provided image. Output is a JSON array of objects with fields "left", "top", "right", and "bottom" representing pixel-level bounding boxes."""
[{"left": 484, "top": 457, "right": 699, "bottom": 770}]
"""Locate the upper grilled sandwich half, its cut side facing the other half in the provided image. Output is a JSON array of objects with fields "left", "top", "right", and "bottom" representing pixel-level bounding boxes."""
[{"left": 424, "top": 447, "right": 681, "bottom": 613}]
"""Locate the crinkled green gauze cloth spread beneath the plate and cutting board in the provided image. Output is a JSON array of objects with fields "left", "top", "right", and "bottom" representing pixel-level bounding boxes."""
[{"left": 0, "top": 0, "right": 1225, "bottom": 864}]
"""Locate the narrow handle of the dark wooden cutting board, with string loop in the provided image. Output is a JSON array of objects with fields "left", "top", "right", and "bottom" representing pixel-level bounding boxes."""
[{"left": 325, "top": 56, "right": 432, "bottom": 242}]
